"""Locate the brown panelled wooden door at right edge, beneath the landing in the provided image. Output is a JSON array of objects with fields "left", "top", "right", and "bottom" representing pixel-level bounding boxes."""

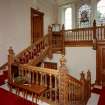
[{"left": 96, "top": 44, "right": 105, "bottom": 85}]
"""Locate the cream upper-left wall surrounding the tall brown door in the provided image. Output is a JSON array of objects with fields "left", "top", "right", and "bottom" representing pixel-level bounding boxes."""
[{"left": 0, "top": 0, "right": 57, "bottom": 66}]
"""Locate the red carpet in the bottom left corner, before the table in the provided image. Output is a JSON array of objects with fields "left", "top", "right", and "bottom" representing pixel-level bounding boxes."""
[{"left": 0, "top": 88, "right": 37, "bottom": 105}]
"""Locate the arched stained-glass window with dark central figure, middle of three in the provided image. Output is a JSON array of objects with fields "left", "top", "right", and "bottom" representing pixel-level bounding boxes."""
[{"left": 78, "top": 4, "right": 91, "bottom": 27}]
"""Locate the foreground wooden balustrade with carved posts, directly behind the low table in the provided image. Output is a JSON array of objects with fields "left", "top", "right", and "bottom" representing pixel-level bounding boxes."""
[{"left": 8, "top": 45, "right": 91, "bottom": 105}]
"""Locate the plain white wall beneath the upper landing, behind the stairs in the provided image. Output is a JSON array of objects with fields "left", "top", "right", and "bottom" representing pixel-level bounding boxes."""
[{"left": 45, "top": 47, "right": 96, "bottom": 83}]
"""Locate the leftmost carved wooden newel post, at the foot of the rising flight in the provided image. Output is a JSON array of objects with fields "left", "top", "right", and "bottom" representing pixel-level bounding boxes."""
[{"left": 8, "top": 47, "right": 15, "bottom": 81}]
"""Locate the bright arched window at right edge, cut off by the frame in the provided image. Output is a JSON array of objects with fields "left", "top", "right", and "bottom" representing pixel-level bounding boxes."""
[{"left": 97, "top": 0, "right": 105, "bottom": 24}]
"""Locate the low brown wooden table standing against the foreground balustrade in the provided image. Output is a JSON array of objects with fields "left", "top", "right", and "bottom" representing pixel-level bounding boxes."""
[{"left": 9, "top": 82, "right": 47, "bottom": 103}]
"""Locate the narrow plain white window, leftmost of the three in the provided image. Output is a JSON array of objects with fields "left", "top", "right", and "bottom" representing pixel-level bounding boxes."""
[{"left": 65, "top": 7, "right": 72, "bottom": 29}]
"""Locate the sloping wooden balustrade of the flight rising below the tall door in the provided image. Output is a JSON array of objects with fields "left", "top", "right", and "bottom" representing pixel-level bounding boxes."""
[{"left": 11, "top": 35, "right": 49, "bottom": 65}]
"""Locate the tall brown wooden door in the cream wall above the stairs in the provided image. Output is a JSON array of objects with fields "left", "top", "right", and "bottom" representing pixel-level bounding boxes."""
[{"left": 31, "top": 8, "right": 44, "bottom": 43}]
